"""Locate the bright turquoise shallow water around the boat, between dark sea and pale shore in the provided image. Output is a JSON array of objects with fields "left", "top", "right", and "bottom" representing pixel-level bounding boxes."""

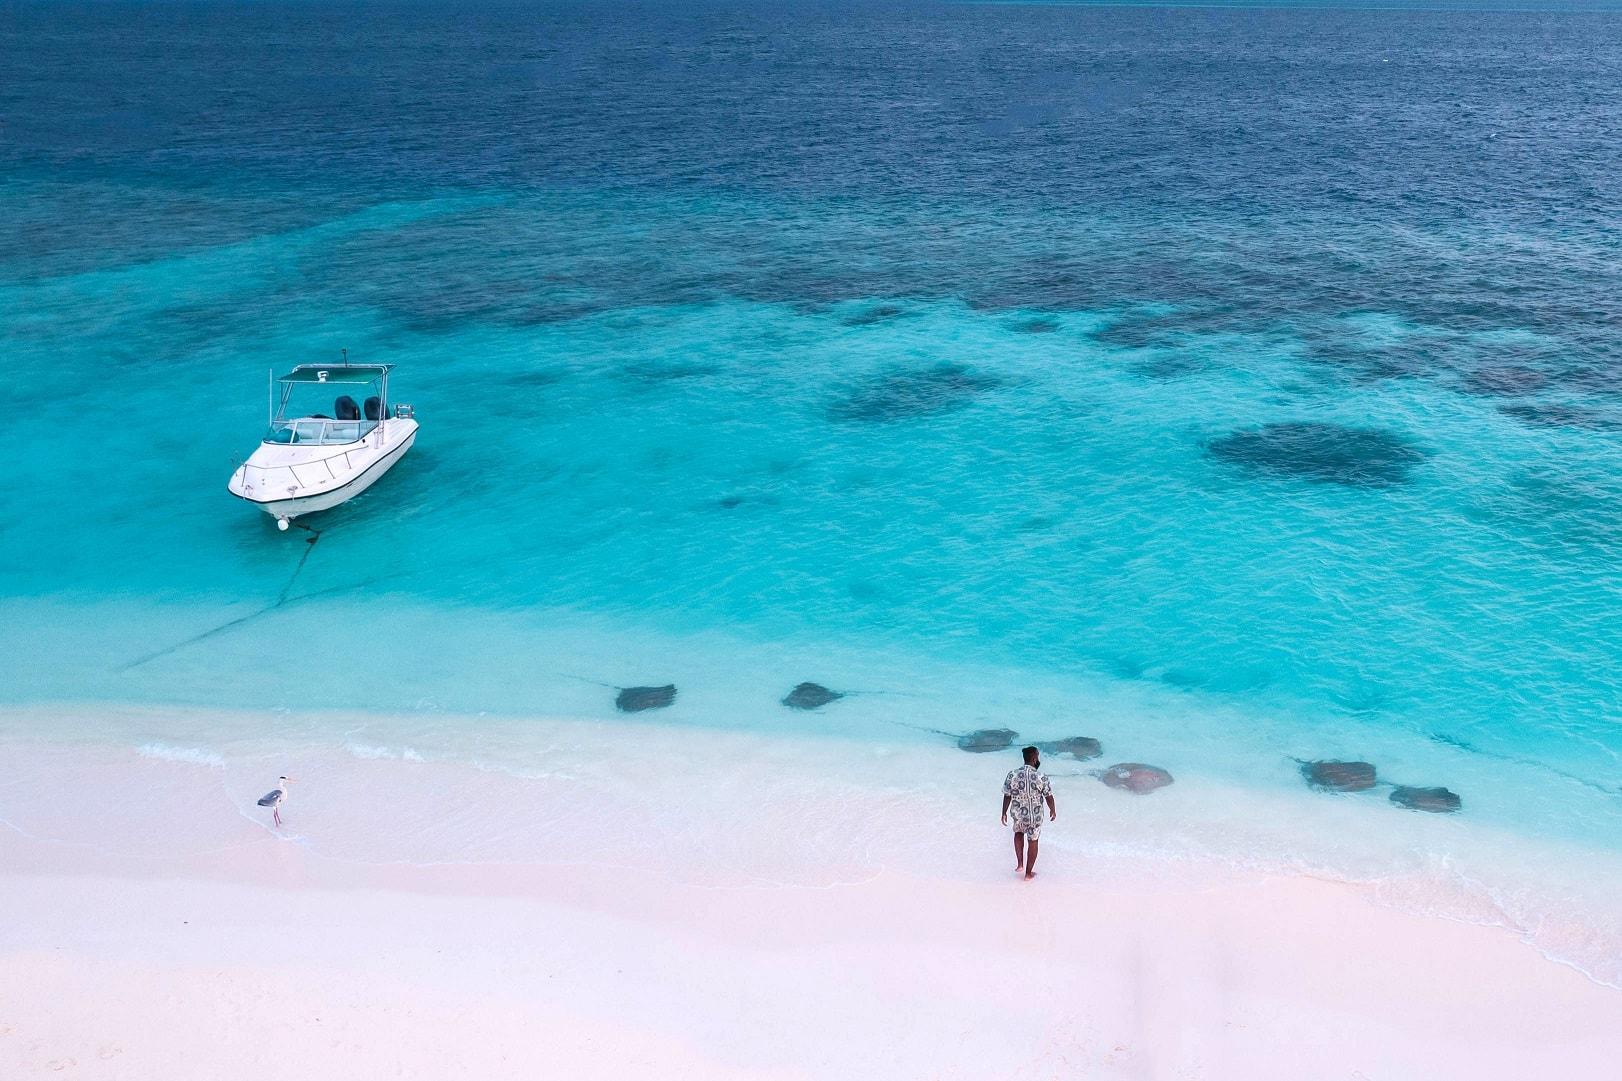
[{"left": 3, "top": 185, "right": 1622, "bottom": 816}]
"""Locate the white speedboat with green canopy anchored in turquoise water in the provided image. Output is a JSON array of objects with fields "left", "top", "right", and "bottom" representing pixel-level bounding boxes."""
[{"left": 225, "top": 364, "right": 417, "bottom": 529}]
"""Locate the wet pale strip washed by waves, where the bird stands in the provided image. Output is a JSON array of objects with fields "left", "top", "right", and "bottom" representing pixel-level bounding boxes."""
[{"left": 9, "top": 706, "right": 1622, "bottom": 990}]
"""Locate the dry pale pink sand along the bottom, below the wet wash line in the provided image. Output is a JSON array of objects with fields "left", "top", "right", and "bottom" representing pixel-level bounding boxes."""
[{"left": 0, "top": 812, "right": 1622, "bottom": 1081}]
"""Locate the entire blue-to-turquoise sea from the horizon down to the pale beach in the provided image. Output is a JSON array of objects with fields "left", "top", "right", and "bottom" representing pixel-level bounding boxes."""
[{"left": 0, "top": 2, "right": 1622, "bottom": 915}]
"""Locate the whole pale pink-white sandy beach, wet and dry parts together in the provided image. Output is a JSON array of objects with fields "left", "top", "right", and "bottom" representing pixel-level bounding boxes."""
[{"left": 0, "top": 704, "right": 1622, "bottom": 1081}]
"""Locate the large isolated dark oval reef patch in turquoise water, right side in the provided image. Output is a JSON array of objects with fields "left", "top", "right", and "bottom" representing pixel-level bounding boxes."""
[{"left": 1207, "top": 420, "right": 1424, "bottom": 489}]
